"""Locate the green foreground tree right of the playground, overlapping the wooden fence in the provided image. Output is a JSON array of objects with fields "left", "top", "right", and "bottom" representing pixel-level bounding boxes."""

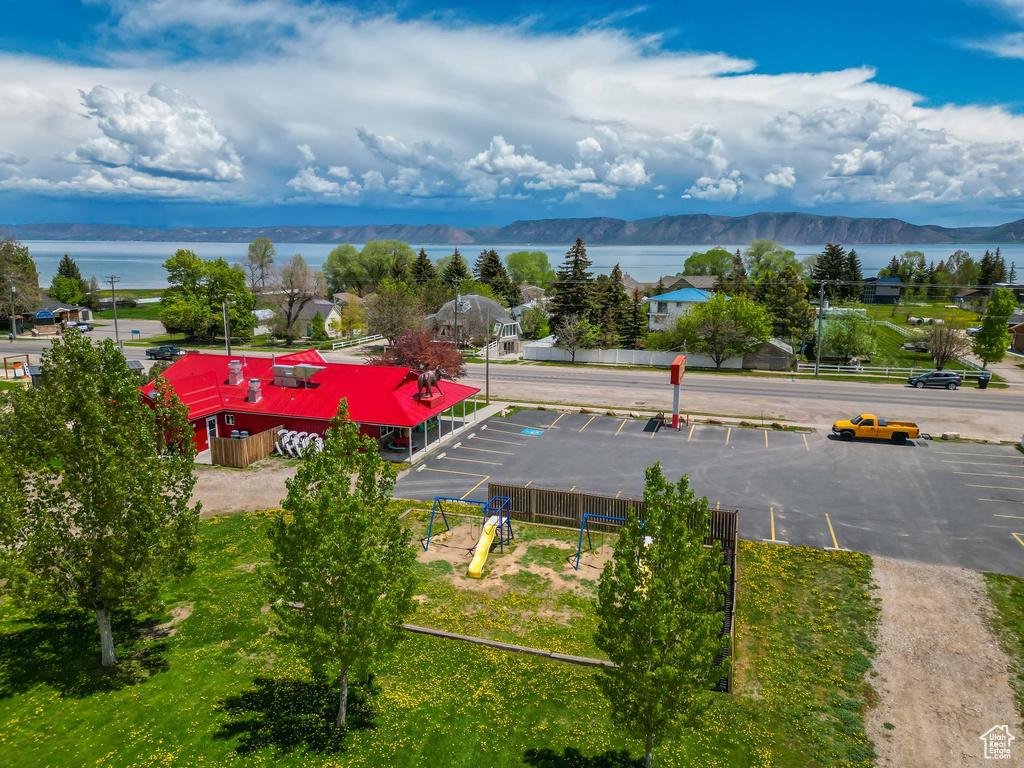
[{"left": 594, "top": 464, "right": 729, "bottom": 768}]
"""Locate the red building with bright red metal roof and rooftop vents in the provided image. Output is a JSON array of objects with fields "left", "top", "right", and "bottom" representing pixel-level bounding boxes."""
[{"left": 142, "top": 349, "right": 480, "bottom": 462}]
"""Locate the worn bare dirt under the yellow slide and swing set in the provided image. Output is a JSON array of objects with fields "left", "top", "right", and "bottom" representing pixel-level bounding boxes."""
[{"left": 419, "top": 521, "right": 612, "bottom": 596}]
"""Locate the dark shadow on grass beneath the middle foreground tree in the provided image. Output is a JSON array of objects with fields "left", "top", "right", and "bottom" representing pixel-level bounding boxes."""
[{"left": 214, "top": 676, "right": 378, "bottom": 755}]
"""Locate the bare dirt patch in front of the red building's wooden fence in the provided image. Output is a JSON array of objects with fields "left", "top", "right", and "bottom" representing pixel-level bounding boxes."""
[{"left": 191, "top": 459, "right": 298, "bottom": 517}]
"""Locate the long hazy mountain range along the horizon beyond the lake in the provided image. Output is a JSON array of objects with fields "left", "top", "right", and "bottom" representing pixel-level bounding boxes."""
[{"left": 6, "top": 213, "right": 1024, "bottom": 246}]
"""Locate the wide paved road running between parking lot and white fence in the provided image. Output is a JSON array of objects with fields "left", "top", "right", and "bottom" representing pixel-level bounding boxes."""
[{"left": 9, "top": 333, "right": 1024, "bottom": 440}]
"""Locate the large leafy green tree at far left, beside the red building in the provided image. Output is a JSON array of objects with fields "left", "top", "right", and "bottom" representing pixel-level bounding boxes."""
[{"left": 0, "top": 334, "right": 200, "bottom": 667}]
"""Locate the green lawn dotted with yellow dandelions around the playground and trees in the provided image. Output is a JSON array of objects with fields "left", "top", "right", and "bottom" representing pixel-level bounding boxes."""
[{"left": 0, "top": 502, "right": 877, "bottom": 768}]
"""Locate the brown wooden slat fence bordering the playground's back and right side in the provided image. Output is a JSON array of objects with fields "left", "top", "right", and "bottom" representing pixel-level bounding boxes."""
[{"left": 487, "top": 482, "right": 739, "bottom": 692}]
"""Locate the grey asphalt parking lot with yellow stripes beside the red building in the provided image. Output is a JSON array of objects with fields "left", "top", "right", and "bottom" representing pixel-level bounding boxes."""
[{"left": 395, "top": 411, "right": 1024, "bottom": 575}]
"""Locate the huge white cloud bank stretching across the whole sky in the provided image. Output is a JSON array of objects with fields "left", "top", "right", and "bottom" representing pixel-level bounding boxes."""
[{"left": 0, "top": 0, "right": 1024, "bottom": 213}]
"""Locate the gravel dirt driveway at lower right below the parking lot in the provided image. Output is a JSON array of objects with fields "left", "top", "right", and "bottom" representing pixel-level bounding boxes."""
[{"left": 866, "top": 557, "right": 1024, "bottom": 768}]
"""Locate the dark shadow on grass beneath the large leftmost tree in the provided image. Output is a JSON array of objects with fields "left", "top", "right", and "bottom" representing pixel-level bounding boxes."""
[{"left": 0, "top": 611, "right": 170, "bottom": 698}]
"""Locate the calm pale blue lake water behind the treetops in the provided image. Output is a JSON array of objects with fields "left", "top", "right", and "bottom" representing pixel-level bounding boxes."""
[{"left": 24, "top": 240, "right": 1024, "bottom": 288}]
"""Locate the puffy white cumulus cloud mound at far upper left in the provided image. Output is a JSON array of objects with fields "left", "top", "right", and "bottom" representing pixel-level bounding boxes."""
[{"left": 67, "top": 83, "right": 242, "bottom": 181}]
